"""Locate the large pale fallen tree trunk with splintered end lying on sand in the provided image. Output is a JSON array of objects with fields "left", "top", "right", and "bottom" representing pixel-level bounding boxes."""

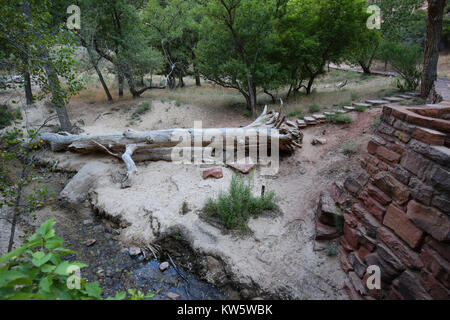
[{"left": 40, "top": 106, "right": 303, "bottom": 188}]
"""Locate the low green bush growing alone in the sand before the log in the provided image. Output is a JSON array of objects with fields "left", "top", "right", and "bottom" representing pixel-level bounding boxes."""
[{"left": 204, "top": 174, "right": 279, "bottom": 231}]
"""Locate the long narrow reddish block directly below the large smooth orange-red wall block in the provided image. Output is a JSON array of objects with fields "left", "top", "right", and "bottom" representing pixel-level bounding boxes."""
[{"left": 378, "top": 228, "right": 423, "bottom": 269}]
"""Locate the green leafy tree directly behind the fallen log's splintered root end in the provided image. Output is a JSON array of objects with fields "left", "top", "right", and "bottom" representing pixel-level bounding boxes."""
[{"left": 195, "top": 0, "right": 280, "bottom": 115}]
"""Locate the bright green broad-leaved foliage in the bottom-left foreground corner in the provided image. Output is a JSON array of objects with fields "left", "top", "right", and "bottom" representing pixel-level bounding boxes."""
[{"left": 0, "top": 219, "right": 153, "bottom": 300}]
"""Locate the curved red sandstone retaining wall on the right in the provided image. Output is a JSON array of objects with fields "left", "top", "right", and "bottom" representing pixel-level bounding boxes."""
[{"left": 317, "top": 105, "right": 450, "bottom": 299}]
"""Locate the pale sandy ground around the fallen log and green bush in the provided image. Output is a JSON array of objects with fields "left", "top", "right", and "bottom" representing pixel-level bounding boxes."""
[{"left": 5, "top": 93, "right": 380, "bottom": 299}]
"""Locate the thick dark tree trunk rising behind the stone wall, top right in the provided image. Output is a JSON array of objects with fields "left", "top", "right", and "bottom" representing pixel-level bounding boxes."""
[{"left": 420, "top": 0, "right": 445, "bottom": 99}]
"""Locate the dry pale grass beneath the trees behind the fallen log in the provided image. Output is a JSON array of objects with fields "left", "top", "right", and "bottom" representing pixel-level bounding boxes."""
[{"left": 73, "top": 70, "right": 395, "bottom": 117}]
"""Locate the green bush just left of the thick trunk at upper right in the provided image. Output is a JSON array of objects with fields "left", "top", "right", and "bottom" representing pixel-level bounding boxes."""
[{"left": 384, "top": 42, "right": 423, "bottom": 91}]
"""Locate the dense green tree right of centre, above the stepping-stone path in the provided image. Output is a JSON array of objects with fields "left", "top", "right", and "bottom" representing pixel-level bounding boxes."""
[{"left": 277, "top": 0, "right": 366, "bottom": 94}]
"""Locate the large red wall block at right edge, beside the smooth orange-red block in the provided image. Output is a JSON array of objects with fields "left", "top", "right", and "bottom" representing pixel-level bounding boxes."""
[{"left": 406, "top": 200, "right": 450, "bottom": 241}]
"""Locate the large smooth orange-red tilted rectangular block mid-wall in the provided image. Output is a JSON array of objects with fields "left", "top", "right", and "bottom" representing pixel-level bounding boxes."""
[{"left": 383, "top": 204, "right": 423, "bottom": 249}]
